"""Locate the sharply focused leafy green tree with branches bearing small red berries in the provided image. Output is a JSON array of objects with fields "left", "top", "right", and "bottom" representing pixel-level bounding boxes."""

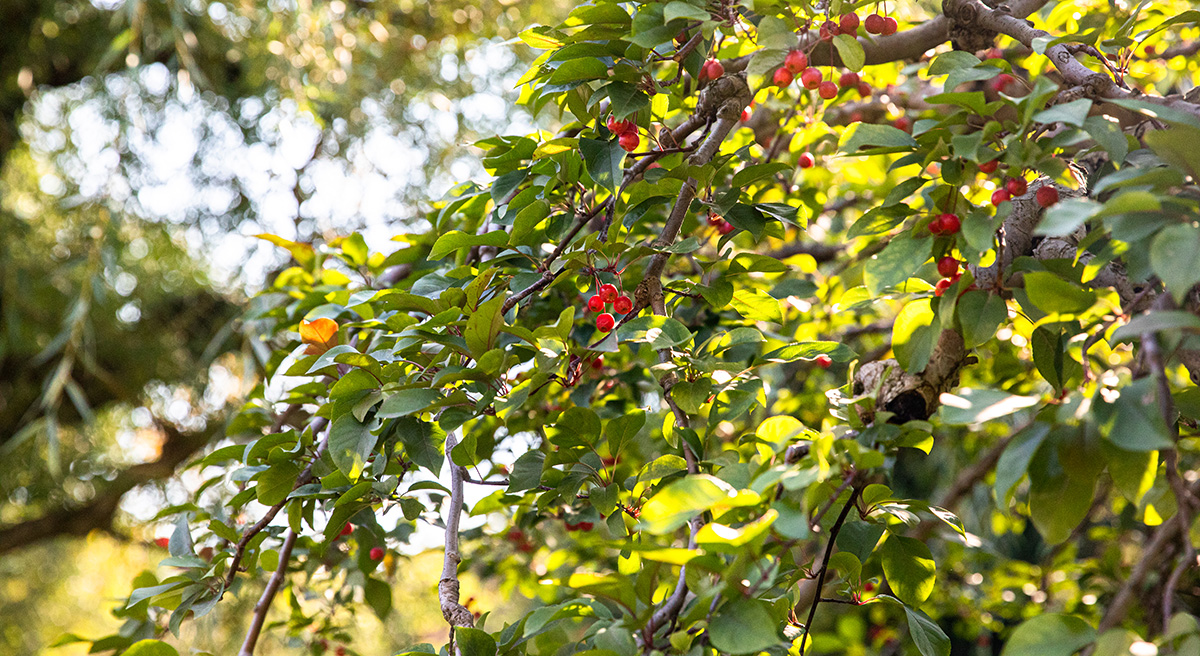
[{"left": 2, "top": 0, "right": 1200, "bottom": 656}]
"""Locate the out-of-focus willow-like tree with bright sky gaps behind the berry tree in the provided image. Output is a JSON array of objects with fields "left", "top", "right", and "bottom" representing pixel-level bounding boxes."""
[{"left": 0, "top": 0, "right": 570, "bottom": 654}]
